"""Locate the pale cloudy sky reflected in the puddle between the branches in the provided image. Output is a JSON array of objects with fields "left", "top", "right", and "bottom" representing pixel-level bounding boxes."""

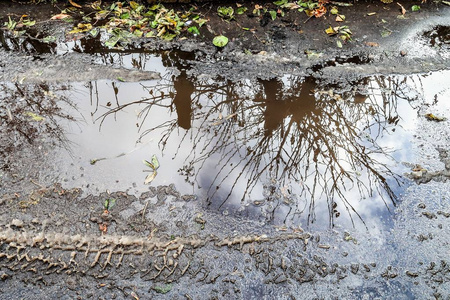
[{"left": 51, "top": 65, "right": 448, "bottom": 231}]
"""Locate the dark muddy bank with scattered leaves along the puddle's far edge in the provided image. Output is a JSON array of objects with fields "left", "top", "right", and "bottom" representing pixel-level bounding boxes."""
[{"left": 0, "top": 2, "right": 450, "bottom": 81}]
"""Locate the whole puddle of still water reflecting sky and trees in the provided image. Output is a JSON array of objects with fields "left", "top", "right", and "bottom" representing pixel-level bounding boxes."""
[{"left": 14, "top": 51, "right": 442, "bottom": 230}]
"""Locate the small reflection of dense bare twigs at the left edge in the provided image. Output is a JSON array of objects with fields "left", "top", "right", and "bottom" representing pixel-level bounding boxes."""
[{"left": 0, "top": 83, "right": 74, "bottom": 168}]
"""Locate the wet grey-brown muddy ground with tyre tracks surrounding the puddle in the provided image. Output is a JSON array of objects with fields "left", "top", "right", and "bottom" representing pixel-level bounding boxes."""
[{"left": 0, "top": 1, "right": 450, "bottom": 299}]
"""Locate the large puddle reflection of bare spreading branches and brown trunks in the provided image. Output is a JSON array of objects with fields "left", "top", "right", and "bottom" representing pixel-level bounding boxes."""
[{"left": 96, "top": 61, "right": 426, "bottom": 224}]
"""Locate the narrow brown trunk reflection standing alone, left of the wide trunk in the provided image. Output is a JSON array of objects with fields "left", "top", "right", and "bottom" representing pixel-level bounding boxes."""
[{"left": 173, "top": 71, "right": 195, "bottom": 129}]
